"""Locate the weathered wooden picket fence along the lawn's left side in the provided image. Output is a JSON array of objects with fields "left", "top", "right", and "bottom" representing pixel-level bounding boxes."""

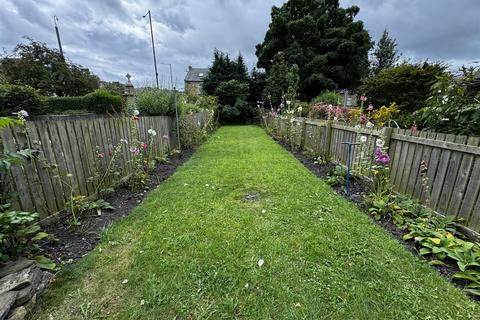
[{"left": 0, "top": 114, "right": 206, "bottom": 217}]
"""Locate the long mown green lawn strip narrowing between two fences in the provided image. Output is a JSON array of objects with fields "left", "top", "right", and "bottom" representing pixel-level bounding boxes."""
[{"left": 34, "top": 126, "right": 479, "bottom": 319}]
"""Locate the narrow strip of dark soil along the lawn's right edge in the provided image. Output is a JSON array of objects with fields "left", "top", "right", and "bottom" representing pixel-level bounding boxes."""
[{"left": 275, "top": 139, "right": 474, "bottom": 302}]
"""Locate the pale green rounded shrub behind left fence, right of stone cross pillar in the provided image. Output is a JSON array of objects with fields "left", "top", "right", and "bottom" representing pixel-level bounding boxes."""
[{"left": 129, "top": 88, "right": 175, "bottom": 116}]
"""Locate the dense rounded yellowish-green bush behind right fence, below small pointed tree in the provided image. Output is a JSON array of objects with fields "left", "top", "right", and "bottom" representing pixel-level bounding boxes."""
[{"left": 359, "top": 62, "right": 445, "bottom": 126}]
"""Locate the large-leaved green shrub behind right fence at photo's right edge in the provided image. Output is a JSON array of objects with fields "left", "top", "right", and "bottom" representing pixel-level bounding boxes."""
[{"left": 418, "top": 68, "right": 480, "bottom": 135}]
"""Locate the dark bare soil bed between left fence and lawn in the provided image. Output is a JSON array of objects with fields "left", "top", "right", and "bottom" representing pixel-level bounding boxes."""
[{"left": 41, "top": 149, "right": 195, "bottom": 263}]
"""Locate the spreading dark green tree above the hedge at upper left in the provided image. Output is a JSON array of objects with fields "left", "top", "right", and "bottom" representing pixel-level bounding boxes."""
[{"left": 0, "top": 38, "right": 99, "bottom": 96}]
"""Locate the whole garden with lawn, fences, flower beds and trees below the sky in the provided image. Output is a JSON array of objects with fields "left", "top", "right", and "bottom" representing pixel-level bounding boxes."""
[{"left": 0, "top": 0, "right": 480, "bottom": 320}]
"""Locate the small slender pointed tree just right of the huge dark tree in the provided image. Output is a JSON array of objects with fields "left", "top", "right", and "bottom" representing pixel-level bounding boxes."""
[{"left": 372, "top": 29, "right": 400, "bottom": 74}]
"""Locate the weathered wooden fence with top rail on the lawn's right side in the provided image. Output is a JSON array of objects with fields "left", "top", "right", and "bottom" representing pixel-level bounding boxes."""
[{"left": 267, "top": 117, "right": 480, "bottom": 232}]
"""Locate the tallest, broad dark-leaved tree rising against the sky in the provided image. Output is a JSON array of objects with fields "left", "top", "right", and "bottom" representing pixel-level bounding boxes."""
[{"left": 256, "top": 0, "right": 372, "bottom": 99}]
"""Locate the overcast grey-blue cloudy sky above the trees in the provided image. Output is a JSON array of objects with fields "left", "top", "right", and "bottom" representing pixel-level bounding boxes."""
[{"left": 0, "top": 0, "right": 480, "bottom": 88}]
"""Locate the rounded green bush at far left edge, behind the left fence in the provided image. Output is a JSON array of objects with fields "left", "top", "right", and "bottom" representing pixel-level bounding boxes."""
[{"left": 0, "top": 84, "right": 46, "bottom": 116}]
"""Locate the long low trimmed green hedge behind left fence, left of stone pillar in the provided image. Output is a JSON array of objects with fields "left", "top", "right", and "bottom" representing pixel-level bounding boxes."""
[{"left": 45, "top": 89, "right": 122, "bottom": 114}]
